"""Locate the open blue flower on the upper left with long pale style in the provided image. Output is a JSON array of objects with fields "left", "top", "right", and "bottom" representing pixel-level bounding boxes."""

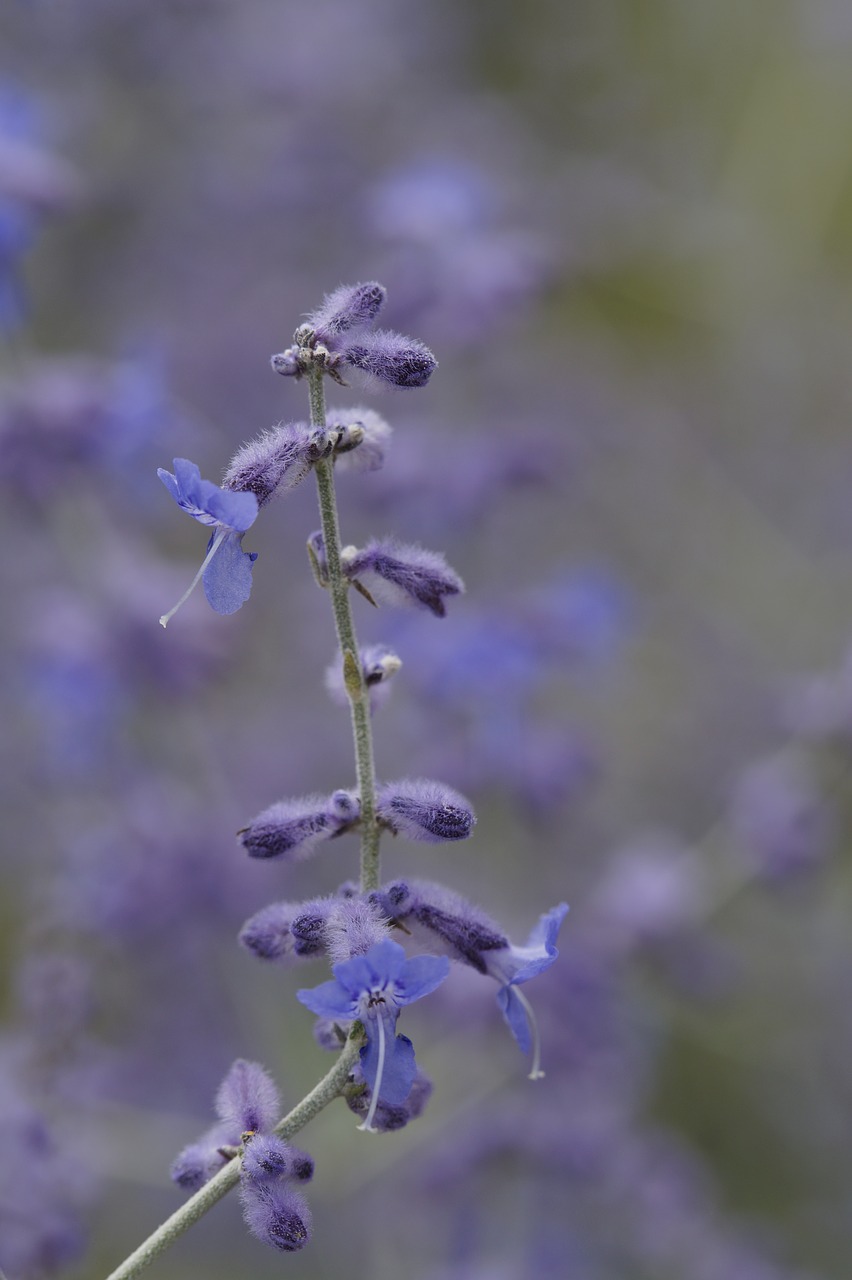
[{"left": 157, "top": 458, "right": 257, "bottom": 627}]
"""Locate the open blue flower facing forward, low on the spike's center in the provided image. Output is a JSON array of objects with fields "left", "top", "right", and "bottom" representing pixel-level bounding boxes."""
[{"left": 297, "top": 938, "right": 449, "bottom": 1133}]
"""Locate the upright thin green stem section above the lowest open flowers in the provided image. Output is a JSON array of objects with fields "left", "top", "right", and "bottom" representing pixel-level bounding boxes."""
[{"left": 308, "top": 365, "right": 381, "bottom": 893}]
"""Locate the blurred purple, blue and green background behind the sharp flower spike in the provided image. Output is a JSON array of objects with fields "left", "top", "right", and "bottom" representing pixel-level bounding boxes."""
[{"left": 0, "top": 0, "right": 852, "bottom": 1280}]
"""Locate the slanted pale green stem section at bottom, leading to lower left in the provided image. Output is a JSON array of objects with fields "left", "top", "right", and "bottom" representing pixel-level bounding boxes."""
[{"left": 107, "top": 1027, "right": 363, "bottom": 1280}]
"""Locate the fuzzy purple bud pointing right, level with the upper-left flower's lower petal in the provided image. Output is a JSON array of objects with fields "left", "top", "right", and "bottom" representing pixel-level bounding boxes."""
[{"left": 344, "top": 538, "right": 464, "bottom": 618}]
